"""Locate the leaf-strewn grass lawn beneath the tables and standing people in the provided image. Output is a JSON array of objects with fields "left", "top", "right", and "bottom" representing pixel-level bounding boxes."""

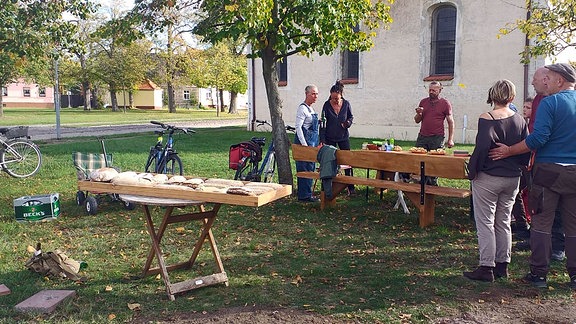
[{"left": 0, "top": 113, "right": 572, "bottom": 323}]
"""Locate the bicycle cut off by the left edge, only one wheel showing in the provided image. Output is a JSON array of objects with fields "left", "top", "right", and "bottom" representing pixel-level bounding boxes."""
[{"left": 0, "top": 126, "right": 42, "bottom": 178}]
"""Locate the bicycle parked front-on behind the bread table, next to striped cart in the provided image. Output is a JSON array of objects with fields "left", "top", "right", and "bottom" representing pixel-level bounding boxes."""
[{"left": 144, "top": 120, "right": 196, "bottom": 175}]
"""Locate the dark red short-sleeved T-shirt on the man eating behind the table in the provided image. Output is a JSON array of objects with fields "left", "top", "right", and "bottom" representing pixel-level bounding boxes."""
[{"left": 420, "top": 97, "right": 452, "bottom": 136}]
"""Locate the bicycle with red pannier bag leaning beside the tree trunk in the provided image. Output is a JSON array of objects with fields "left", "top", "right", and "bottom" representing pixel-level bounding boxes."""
[{"left": 229, "top": 120, "right": 296, "bottom": 182}]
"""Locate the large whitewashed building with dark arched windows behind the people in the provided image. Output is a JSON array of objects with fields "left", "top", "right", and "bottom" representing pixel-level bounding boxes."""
[{"left": 248, "top": 0, "right": 544, "bottom": 143}]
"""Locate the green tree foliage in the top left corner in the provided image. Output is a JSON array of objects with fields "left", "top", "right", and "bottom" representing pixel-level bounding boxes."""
[{"left": 0, "top": 0, "right": 94, "bottom": 117}]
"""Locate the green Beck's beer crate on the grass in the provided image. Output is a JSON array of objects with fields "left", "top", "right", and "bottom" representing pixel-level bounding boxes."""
[{"left": 14, "top": 193, "right": 60, "bottom": 222}]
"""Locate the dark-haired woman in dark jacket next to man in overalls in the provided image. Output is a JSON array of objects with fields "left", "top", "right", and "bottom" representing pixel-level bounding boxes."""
[{"left": 320, "top": 80, "right": 355, "bottom": 194}]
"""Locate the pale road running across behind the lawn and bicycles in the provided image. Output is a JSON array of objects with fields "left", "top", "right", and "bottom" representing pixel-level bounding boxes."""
[{"left": 28, "top": 118, "right": 247, "bottom": 140}]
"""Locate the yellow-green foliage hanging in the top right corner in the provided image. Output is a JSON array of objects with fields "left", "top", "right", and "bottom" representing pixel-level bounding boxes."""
[{"left": 500, "top": 0, "right": 576, "bottom": 63}]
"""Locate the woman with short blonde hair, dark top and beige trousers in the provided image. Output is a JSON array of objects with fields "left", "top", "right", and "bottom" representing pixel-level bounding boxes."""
[{"left": 464, "top": 80, "right": 530, "bottom": 281}]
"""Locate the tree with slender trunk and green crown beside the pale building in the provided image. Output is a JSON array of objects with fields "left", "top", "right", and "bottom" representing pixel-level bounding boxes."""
[{"left": 195, "top": 0, "right": 394, "bottom": 184}]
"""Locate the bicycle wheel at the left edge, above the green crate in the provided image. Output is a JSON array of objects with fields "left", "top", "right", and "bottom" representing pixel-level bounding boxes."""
[{"left": 0, "top": 139, "right": 42, "bottom": 178}]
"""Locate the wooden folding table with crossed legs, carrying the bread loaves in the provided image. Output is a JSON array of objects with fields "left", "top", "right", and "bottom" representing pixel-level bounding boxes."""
[{"left": 78, "top": 180, "right": 292, "bottom": 300}]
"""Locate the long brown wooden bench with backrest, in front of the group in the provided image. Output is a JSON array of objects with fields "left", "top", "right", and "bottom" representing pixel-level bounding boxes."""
[{"left": 292, "top": 144, "right": 471, "bottom": 227}]
